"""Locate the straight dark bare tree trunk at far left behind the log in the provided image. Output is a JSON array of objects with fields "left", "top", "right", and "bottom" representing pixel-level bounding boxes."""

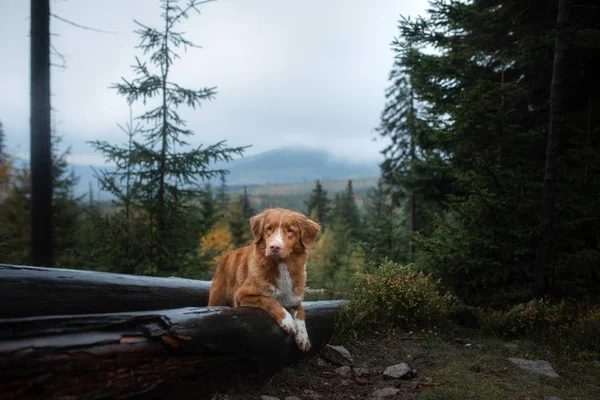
[{"left": 30, "top": 0, "right": 52, "bottom": 266}]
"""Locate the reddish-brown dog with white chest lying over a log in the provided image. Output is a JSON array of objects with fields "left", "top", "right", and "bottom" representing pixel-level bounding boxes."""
[{"left": 208, "top": 208, "right": 321, "bottom": 352}]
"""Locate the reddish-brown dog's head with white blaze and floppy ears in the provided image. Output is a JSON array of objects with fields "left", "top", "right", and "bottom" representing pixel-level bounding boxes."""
[{"left": 250, "top": 208, "right": 321, "bottom": 259}]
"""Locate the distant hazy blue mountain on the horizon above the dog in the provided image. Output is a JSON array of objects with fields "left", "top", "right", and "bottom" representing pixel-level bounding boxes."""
[{"left": 72, "top": 147, "right": 379, "bottom": 199}]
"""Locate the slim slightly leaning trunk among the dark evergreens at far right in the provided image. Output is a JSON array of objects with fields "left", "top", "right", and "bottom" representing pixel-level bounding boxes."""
[{"left": 534, "top": 0, "right": 569, "bottom": 297}]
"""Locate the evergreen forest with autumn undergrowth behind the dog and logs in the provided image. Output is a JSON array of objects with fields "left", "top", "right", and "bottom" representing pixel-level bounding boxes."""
[{"left": 0, "top": 0, "right": 600, "bottom": 396}]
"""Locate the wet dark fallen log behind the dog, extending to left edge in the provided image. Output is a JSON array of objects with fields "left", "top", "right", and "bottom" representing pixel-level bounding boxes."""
[{"left": 0, "top": 264, "right": 211, "bottom": 318}]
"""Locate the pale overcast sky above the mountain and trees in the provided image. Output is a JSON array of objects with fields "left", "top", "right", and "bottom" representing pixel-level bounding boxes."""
[{"left": 0, "top": 0, "right": 427, "bottom": 165}]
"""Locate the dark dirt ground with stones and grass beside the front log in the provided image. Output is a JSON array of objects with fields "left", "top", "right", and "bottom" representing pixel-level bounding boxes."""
[{"left": 196, "top": 331, "right": 600, "bottom": 400}]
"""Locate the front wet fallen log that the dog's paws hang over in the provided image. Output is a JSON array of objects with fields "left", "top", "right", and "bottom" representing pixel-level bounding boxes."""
[{"left": 0, "top": 301, "right": 340, "bottom": 399}]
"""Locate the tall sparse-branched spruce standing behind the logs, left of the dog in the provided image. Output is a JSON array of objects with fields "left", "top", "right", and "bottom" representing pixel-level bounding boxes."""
[{"left": 87, "top": 0, "right": 244, "bottom": 275}]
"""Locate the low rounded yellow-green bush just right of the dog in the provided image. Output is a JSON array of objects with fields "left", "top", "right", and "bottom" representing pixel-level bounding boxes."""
[{"left": 334, "top": 261, "right": 456, "bottom": 340}]
